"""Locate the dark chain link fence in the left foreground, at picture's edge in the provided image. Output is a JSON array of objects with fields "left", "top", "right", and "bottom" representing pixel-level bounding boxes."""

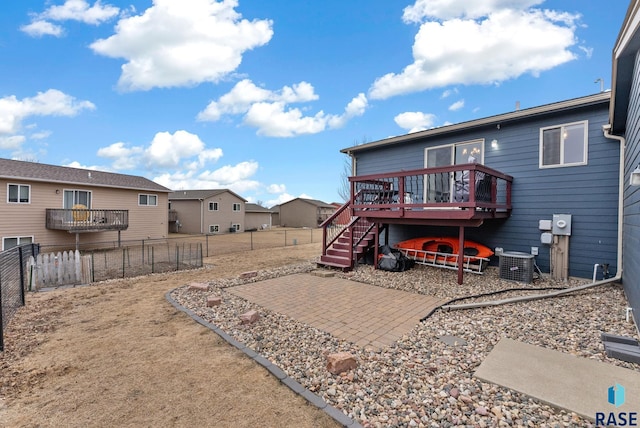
[{"left": 0, "top": 244, "right": 39, "bottom": 351}]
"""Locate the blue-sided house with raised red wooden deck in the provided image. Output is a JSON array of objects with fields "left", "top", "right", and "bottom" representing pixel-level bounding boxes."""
[{"left": 328, "top": 92, "right": 616, "bottom": 282}]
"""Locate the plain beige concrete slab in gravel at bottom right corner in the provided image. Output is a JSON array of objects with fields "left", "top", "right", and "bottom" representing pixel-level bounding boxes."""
[{"left": 475, "top": 338, "right": 640, "bottom": 420}]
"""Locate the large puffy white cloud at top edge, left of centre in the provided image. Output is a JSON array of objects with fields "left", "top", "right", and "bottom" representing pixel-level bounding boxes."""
[{"left": 91, "top": 0, "right": 273, "bottom": 91}]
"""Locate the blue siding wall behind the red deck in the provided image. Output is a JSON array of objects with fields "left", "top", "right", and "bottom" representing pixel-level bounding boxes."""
[{"left": 355, "top": 102, "right": 620, "bottom": 278}]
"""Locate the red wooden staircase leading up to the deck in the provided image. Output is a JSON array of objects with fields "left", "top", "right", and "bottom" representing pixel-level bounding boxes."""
[{"left": 318, "top": 198, "right": 379, "bottom": 271}]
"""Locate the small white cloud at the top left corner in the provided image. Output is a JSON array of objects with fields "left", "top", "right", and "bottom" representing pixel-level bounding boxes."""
[{"left": 20, "top": 0, "right": 120, "bottom": 37}]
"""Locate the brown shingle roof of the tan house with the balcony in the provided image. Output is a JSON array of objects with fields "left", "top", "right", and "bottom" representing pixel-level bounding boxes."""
[{"left": 0, "top": 158, "right": 171, "bottom": 193}]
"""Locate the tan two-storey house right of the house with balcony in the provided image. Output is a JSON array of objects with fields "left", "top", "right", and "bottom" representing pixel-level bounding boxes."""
[{"left": 169, "top": 189, "right": 247, "bottom": 233}]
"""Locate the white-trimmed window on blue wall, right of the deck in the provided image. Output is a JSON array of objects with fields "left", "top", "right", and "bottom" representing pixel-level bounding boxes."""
[{"left": 540, "top": 120, "right": 589, "bottom": 168}]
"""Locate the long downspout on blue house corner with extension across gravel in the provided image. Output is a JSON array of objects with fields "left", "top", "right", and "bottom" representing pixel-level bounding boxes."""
[{"left": 440, "top": 124, "right": 624, "bottom": 310}]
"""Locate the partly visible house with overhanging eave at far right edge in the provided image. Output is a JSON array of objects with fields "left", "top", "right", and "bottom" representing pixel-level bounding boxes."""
[{"left": 609, "top": 1, "right": 640, "bottom": 326}]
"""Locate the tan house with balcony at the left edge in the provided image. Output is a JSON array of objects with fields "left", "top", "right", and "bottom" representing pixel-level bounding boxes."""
[{"left": 0, "top": 159, "right": 170, "bottom": 250}]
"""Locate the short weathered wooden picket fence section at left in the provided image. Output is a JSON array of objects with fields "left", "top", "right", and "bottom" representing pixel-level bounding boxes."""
[{"left": 27, "top": 250, "right": 91, "bottom": 290}]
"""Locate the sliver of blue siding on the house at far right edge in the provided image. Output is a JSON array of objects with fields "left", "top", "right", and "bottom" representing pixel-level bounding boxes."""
[{"left": 622, "top": 49, "right": 640, "bottom": 325}]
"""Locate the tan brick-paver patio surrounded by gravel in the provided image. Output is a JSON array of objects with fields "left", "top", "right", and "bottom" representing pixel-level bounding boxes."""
[{"left": 227, "top": 274, "right": 444, "bottom": 349}]
